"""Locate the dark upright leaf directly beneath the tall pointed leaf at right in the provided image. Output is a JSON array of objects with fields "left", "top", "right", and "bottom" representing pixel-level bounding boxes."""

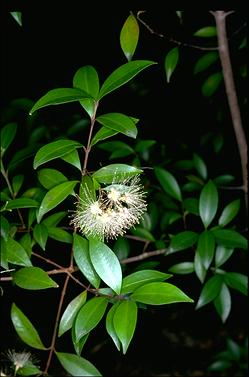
[{"left": 196, "top": 230, "right": 215, "bottom": 270}]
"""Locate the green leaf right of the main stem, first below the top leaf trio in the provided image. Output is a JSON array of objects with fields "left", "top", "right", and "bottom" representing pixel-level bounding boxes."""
[{"left": 96, "top": 113, "right": 137, "bottom": 139}]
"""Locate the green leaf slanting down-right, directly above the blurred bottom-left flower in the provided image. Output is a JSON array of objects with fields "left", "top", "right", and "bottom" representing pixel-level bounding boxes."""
[{"left": 11, "top": 303, "right": 46, "bottom": 350}]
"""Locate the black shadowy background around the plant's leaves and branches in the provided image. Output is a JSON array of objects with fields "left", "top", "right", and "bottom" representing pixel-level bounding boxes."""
[{"left": 0, "top": 5, "right": 248, "bottom": 376}]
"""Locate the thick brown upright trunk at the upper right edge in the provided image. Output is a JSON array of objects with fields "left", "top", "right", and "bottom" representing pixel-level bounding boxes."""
[{"left": 211, "top": 10, "right": 248, "bottom": 209}]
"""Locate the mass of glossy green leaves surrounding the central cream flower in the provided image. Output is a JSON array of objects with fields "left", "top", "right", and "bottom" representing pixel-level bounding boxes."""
[{"left": 1, "top": 8, "right": 247, "bottom": 376}]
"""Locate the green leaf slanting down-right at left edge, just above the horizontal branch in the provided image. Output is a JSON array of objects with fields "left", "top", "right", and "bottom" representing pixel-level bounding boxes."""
[{"left": 6, "top": 237, "right": 32, "bottom": 267}]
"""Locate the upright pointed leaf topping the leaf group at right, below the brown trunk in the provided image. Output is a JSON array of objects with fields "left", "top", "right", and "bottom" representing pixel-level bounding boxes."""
[{"left": 199, "top": 180, "right": 218, "bottom": 228}]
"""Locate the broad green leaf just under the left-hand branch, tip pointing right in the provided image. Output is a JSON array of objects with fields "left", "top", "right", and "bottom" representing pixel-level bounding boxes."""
[{"left": 13, "top": 267, "right": 58, "bottom": 290}]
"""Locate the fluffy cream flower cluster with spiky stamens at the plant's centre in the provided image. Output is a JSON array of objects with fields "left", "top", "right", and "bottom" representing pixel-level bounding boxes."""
[{"left": 71, "top": 176, "right": 146, "bottom": 239}]
